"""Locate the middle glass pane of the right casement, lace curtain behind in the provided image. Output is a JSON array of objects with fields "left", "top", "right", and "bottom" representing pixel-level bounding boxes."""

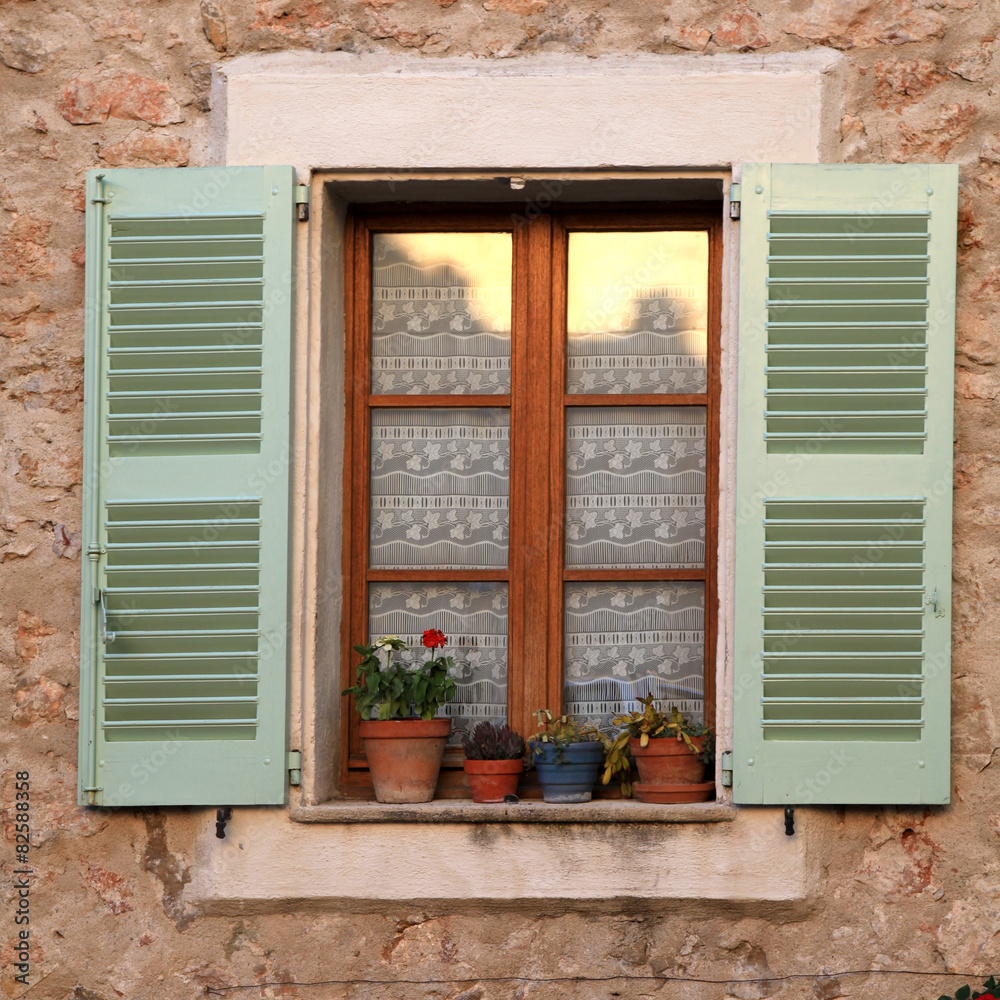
[{"left": 566, "top": 406, "right": 705, "bottom": 569}]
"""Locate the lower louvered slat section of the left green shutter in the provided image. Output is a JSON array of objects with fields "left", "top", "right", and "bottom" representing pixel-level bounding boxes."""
[{"left": 102, "top": 500, "right": 260, "bottom": 740}]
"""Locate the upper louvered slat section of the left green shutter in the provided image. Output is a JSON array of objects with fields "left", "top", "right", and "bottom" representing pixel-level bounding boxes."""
[{"left": 107, "top": 215, "right": 264, "bottom": 455}]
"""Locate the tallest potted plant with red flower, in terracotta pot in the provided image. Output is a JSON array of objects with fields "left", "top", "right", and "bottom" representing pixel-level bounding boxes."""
[{"left": 343, "top": 629, "right": 455, "bottom": 802}]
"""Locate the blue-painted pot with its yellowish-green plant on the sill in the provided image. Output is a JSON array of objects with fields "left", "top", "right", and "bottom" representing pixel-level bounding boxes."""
[{"left": 529, "top": 708, "right": 605, "bottom": 802}]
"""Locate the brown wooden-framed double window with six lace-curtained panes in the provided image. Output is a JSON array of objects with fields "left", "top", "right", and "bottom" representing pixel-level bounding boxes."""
[{"left": 343, "top": 202, "right": 721, "bottom": 791}]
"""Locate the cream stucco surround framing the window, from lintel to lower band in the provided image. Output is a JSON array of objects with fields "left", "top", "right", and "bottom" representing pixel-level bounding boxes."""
[{"left": 182, "top": 52, "right": 843, "bottom": 908}]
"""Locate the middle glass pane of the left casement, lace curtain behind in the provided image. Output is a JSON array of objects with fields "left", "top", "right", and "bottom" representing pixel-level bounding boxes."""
[{"left": 370, "top": 409, "right": 510, "bottom": 569}]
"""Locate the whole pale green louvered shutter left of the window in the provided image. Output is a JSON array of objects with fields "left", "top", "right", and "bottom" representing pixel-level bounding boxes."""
[{"left": 79, "top": 167, "right": 295, "bottom": 806}]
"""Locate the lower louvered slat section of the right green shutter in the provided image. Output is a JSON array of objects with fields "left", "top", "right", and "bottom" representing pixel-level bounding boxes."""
[{"left": 761, "top": 499, "right": 924, "bottom": 740}]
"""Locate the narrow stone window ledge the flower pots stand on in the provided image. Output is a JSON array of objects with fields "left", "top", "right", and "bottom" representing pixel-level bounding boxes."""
[{"left": 291, "top": 799, "right": 737, "bottom": 823}]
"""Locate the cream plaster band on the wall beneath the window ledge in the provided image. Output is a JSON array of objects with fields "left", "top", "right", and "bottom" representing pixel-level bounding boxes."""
[{"left": 195, "top": 800, "right": 819, "bottom": 914}]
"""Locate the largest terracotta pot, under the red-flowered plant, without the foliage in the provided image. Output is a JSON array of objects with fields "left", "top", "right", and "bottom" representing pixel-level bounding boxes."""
[{"left": 359, "top": 719, "right": 451, "bottom": 802}]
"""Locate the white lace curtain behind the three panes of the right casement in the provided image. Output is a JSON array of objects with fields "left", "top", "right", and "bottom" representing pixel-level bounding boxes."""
[{"left": 563, "top": 232, "right": 708, "bottom": 726}]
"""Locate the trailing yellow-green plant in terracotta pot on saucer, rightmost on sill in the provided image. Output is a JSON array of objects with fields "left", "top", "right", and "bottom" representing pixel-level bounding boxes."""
[{"left": 602, "top": 695, "right": 715, "bottom": 802}]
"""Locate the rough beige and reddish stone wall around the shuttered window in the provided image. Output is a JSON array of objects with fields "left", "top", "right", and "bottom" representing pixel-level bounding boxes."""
[{"left": 0, "top": 0, "right": 1000, "bottom": 1000}]
